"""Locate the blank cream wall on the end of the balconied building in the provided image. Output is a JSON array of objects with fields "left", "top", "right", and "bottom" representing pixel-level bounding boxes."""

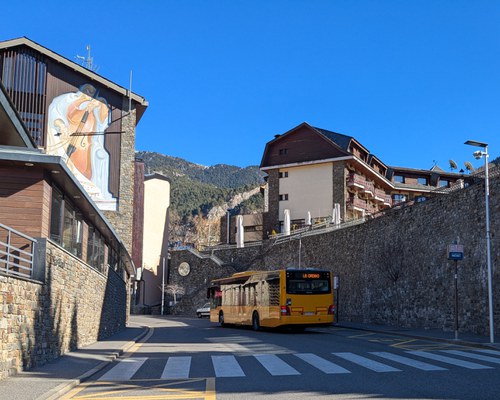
[{"left": 279, "top": 163, "right": 332, "bottom": 225}]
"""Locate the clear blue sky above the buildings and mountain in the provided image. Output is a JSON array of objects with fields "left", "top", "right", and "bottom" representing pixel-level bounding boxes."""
[{"left": 0, "top": 0, "right": 500, "bottom": 170}]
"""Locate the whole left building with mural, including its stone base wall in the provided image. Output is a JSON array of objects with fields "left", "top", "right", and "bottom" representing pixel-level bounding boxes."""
[{"left": 0, "top": 38, "right": 147, "bottom": 379}]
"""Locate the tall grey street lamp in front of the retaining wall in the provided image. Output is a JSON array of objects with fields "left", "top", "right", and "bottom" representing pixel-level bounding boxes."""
[{"left": 465, "top": 140, "right": 495, "bottom": 343}]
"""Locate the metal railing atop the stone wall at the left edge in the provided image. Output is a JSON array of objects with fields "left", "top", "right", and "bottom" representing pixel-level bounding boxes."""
[{"left": 0, "top": 224, "right": 36, "bottom": 278}]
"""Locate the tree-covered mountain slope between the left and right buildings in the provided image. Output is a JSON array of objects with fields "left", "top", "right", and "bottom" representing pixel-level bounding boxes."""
[{"left": 136, "top": 151, "right": 264, "bottom": 244}]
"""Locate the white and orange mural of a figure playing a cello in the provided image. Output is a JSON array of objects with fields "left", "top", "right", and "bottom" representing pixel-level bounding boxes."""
[{"left": 47, "top": 84, "right": 116, "bottom": 211}]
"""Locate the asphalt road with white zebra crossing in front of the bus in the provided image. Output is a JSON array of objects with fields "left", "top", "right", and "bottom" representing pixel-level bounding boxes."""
[{"left": 60, "top": 318, "right": 500, "bottom": 400}]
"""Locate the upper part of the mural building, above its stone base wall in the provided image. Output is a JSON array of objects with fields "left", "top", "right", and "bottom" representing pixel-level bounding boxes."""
[{"left": 0, "top": 37, "right": 148, "bottom": 275}]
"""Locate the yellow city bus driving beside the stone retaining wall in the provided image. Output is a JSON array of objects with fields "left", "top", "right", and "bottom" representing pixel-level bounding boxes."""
[{"left": 208, "top": 269, "right": 335, "bottom": 330}]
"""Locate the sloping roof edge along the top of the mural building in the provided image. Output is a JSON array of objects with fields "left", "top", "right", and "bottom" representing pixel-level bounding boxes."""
[{"left": 0, "top": 37, "right": 148, "bottom": 122}]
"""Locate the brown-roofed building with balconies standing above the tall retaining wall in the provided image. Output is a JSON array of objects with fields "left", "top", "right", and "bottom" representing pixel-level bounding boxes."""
[{"left": 260, "top": 122, "right": 466, "bottom": 234}]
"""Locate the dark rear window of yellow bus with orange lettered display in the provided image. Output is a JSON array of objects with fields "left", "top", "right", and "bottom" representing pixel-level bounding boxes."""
[{"left": 286, "top": 271, "right": 331, "bottom": 294}]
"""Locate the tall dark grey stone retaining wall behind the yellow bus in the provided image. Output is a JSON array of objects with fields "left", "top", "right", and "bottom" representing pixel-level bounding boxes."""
[{"left": 171, "top": 177, "right": 500, "bottom": 334}]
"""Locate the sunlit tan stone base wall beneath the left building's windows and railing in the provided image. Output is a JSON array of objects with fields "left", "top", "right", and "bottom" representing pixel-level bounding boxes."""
[{"left": 0, "top": 239, "right": 128, "bottom": 379}]
